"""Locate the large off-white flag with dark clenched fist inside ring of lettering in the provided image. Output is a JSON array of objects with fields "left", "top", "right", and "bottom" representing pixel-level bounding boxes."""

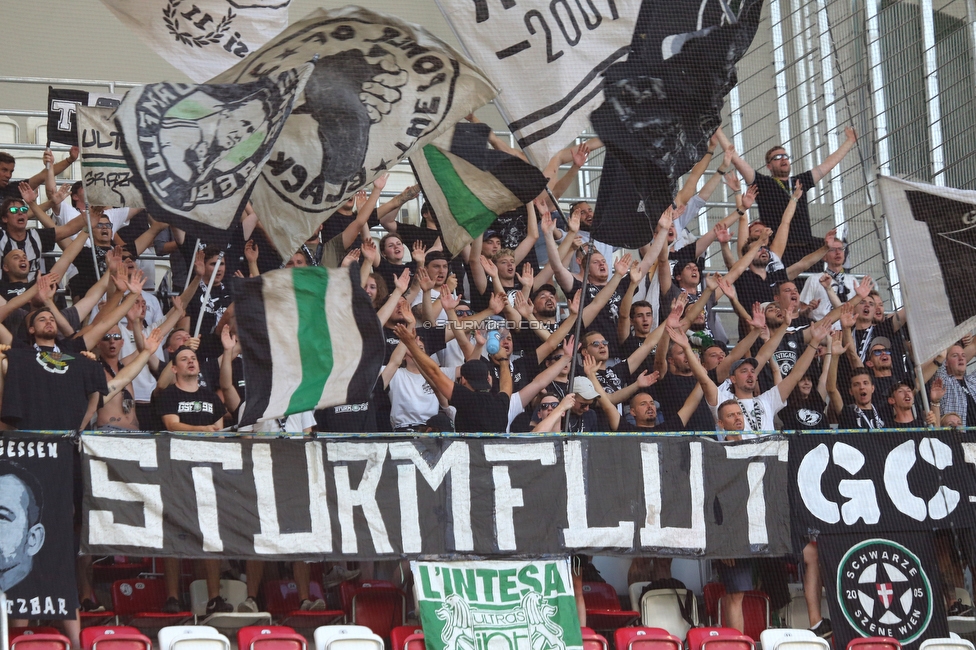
[{"left": 211, "top": 6, "right": 496, "bottom": 259}]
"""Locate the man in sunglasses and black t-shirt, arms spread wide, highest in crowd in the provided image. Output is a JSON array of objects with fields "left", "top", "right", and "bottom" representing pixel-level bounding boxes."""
[{"left": 719, "top": 127, "right": 857, "bottom": 266}]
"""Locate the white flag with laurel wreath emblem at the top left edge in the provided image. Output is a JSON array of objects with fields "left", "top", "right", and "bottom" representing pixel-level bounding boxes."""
[{"left": 102, "top": 0, "right": 291, "bottom": 83}]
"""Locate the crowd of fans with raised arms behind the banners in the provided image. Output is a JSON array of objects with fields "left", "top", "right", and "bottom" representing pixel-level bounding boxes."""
[{"left": 0, "top": 119, "right": 976, "bottom": 635}]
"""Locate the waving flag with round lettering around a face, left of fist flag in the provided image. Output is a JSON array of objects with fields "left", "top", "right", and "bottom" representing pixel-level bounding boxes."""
[{"left": 115, "top": 64, "right": 312, "bottom": 237}]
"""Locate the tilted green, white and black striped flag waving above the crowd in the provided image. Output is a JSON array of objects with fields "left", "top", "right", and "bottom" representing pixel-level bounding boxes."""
[{"left": 410, "top": 122, "right": 547, "bottom": 253}]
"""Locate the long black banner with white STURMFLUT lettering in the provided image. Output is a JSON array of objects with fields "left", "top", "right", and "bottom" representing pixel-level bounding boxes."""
[{"left": 82, "top": 435, "right": 790, "bottom": 560}]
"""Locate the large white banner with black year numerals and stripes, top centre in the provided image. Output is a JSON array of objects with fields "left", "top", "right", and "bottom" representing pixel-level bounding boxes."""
[{"left": 437, "top": 0, "right": 641, "bottom": 168}]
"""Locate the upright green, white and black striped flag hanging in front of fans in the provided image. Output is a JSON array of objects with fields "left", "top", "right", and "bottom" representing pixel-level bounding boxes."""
[{"left": 232, "top": 267, "right": 386, "bottom": 425}]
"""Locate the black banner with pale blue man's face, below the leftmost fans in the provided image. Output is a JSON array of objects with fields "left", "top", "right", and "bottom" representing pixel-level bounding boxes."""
[{"left": 0, "top": 431, "right": 78, "bottom": 619}]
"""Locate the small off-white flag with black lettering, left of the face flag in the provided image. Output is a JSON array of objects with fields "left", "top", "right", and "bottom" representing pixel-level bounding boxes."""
[{"left": 75, "top": 106, "right": 146, "bottom": 208}]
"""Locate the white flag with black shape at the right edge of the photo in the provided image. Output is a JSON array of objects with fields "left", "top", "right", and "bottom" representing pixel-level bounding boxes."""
[{"left": 878, "top": 176, "right": 976, "bottom": 362}]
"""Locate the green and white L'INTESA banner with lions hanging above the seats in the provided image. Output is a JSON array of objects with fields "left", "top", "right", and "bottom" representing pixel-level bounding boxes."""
[{"left": 410, "top": 559, "right": 583, "bottom": 650}]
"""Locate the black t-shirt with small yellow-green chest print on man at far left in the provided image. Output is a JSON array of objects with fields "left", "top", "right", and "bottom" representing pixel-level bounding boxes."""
[{"left": 2, "top": 340, "right": 108, "bottom": 431}]
